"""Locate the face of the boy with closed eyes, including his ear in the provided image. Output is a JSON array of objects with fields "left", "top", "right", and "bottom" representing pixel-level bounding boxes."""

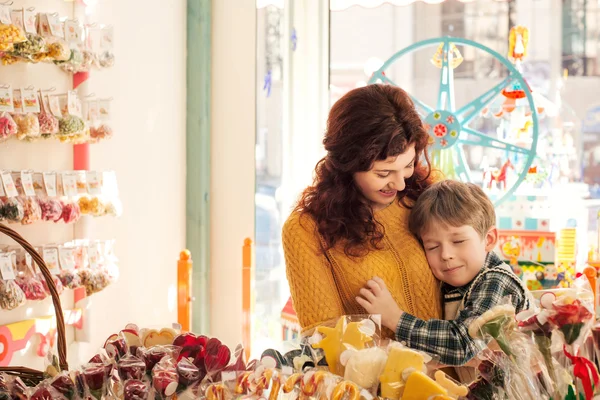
[{"left": 421, "top": 223, "right": 498, "bottom": 287}]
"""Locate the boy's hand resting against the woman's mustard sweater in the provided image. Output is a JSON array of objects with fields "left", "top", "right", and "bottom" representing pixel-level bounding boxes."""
[{"left": 356, "top": 277, "right": 403, "bottom": 331}]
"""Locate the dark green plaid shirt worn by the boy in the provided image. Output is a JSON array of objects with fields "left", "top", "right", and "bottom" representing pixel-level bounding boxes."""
[{"left": 396, "top": 252, "right": 529, "bottom": 366}]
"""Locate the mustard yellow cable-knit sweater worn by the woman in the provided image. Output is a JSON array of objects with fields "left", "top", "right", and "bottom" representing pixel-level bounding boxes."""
[{"left": 282, "top": 202, "right": 442, "bottom": 335}]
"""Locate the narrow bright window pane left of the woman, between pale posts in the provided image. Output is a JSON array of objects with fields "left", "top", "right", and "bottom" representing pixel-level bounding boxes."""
[{"left": 252, "top": 2, "right": 289, "bottom": 351}]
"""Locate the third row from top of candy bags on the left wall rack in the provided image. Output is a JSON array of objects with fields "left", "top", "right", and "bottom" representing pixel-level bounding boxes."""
[{"left": 0, "top": 171, "right": 122, "bottom": 225}]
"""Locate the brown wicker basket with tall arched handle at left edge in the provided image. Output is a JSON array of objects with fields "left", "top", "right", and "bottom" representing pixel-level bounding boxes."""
[{"left": 0, "top": 224, "right": 69, "bottom": 386}]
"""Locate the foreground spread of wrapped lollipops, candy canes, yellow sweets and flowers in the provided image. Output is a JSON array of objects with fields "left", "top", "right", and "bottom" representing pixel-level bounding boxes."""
[{"left": 0, "top": 277, "right": 600, "bottom": 400}]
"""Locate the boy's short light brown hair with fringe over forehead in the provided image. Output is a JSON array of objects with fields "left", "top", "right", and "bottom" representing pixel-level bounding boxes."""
[{"left": 408, "top": 180, "right": 496, "bottom": 239}]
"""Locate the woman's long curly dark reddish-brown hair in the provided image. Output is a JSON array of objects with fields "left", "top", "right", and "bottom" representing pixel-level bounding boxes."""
[{"left": 295, "top": 84, "right": 432, "bottom": 257}]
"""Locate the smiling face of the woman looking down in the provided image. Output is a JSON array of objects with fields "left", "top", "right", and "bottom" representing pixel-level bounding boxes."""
[{"left": 354, "top": 143, "right": 416, "bottom": 211}]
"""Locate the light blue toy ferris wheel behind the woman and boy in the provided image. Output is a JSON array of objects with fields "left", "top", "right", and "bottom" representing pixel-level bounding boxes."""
[{"left": 369, "top": 31, "right": 541, "bottom": 205}]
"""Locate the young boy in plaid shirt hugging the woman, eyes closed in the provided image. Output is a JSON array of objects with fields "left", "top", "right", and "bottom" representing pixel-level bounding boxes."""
[{"left": 356, "top": 180, "right": 529, "bottom": 372}]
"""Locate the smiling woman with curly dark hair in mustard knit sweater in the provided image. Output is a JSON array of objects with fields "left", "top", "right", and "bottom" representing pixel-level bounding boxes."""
[{"left": 283, "top": 85, "right": 441, "bottom": 337}]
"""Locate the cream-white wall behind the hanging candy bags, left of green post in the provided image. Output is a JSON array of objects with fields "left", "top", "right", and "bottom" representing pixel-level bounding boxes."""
[{"left": 0, "top": 0, "right": 186, "bottom": 368}]
